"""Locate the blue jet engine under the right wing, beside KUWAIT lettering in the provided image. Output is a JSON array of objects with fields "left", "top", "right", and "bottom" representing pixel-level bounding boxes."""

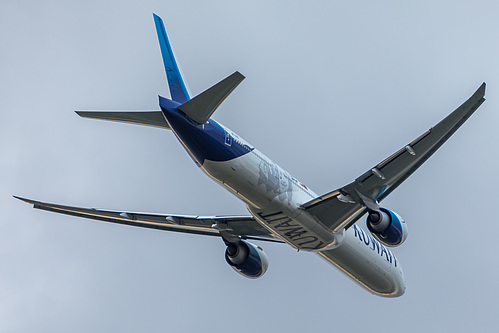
[{"left": 367, "top": 208, "right": 408, "bottom": 246}]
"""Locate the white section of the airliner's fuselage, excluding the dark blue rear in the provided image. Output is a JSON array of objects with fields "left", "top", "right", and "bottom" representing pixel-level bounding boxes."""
[{"left": 201, "top": 127, "right": 405, "bottom": 297}]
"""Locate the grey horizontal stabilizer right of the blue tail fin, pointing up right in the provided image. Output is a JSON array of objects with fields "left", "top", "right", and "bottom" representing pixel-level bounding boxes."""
[{"left": 178, "top": 72, "right": 244, "bottom": 124}]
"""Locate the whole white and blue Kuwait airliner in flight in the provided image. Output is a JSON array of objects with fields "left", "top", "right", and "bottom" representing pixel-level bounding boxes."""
[{"left": 14, "top": 14, "right": 485, "bottom": 297}]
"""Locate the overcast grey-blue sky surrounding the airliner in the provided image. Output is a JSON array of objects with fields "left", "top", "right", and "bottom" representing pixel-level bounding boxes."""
[{"left": 0, "top": 0, "right": 499, "bottom": 333}]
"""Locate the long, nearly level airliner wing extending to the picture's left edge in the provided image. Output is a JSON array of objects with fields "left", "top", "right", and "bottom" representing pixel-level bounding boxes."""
[{"left": 14, "top": 196, "right": 282, "bottom": 243}]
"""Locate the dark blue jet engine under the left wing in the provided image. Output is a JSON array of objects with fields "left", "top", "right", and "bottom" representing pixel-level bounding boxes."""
[{"left": 225, "top": 241, "right": 269, "bottom": 279}]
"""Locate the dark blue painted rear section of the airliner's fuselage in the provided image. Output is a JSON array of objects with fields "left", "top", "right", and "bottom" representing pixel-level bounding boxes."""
[{"left": 159, "top": 96, "right": 254, "bottom": 166}]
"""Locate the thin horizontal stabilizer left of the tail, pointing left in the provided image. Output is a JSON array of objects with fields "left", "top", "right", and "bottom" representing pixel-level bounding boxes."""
[{"left": 76, "top": 111, "right": 170, "bottom": 129}]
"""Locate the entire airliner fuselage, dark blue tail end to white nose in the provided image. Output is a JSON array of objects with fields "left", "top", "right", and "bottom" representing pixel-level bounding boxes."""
[{"left": 160, "top": 99, "right": 405, "bottom": 297}]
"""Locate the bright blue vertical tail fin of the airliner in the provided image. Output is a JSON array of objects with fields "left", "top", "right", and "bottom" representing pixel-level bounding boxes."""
[{"left": 153, "top": 14, "right": 190, "bottom": 104}]
